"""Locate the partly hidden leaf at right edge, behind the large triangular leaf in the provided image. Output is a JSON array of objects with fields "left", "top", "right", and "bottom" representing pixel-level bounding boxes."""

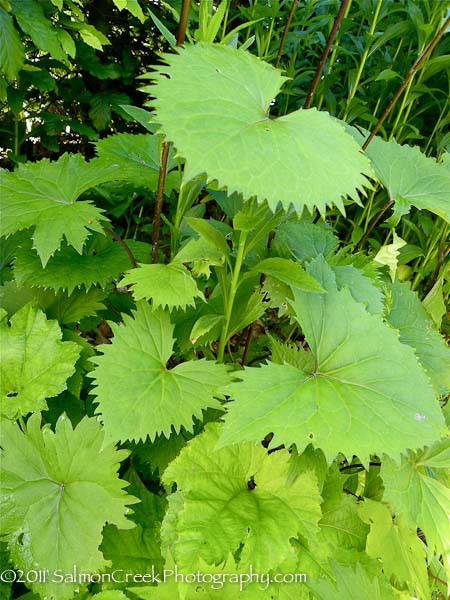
[{"left": 387, "top": 280, "right": 450, "bottom": 394}]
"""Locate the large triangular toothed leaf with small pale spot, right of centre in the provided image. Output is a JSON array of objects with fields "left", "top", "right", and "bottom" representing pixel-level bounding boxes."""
[{"left": 220, "top": 258, "right": 444, "bottom": 464}]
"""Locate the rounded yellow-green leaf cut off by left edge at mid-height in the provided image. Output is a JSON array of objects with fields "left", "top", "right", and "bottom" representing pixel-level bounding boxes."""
[{"left": 0, "top": 304, "right": 80, "bottom": 419}]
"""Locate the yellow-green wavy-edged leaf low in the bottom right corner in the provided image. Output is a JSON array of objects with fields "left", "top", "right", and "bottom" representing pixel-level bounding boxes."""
[{"left": 360, "top": 500, "right": 430, "bottom": 598}]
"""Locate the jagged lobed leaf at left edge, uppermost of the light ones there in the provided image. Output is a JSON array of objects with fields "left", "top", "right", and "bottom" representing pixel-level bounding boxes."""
[{"left": 0, "top": 154, "right": 120, "bottom": 267}]
